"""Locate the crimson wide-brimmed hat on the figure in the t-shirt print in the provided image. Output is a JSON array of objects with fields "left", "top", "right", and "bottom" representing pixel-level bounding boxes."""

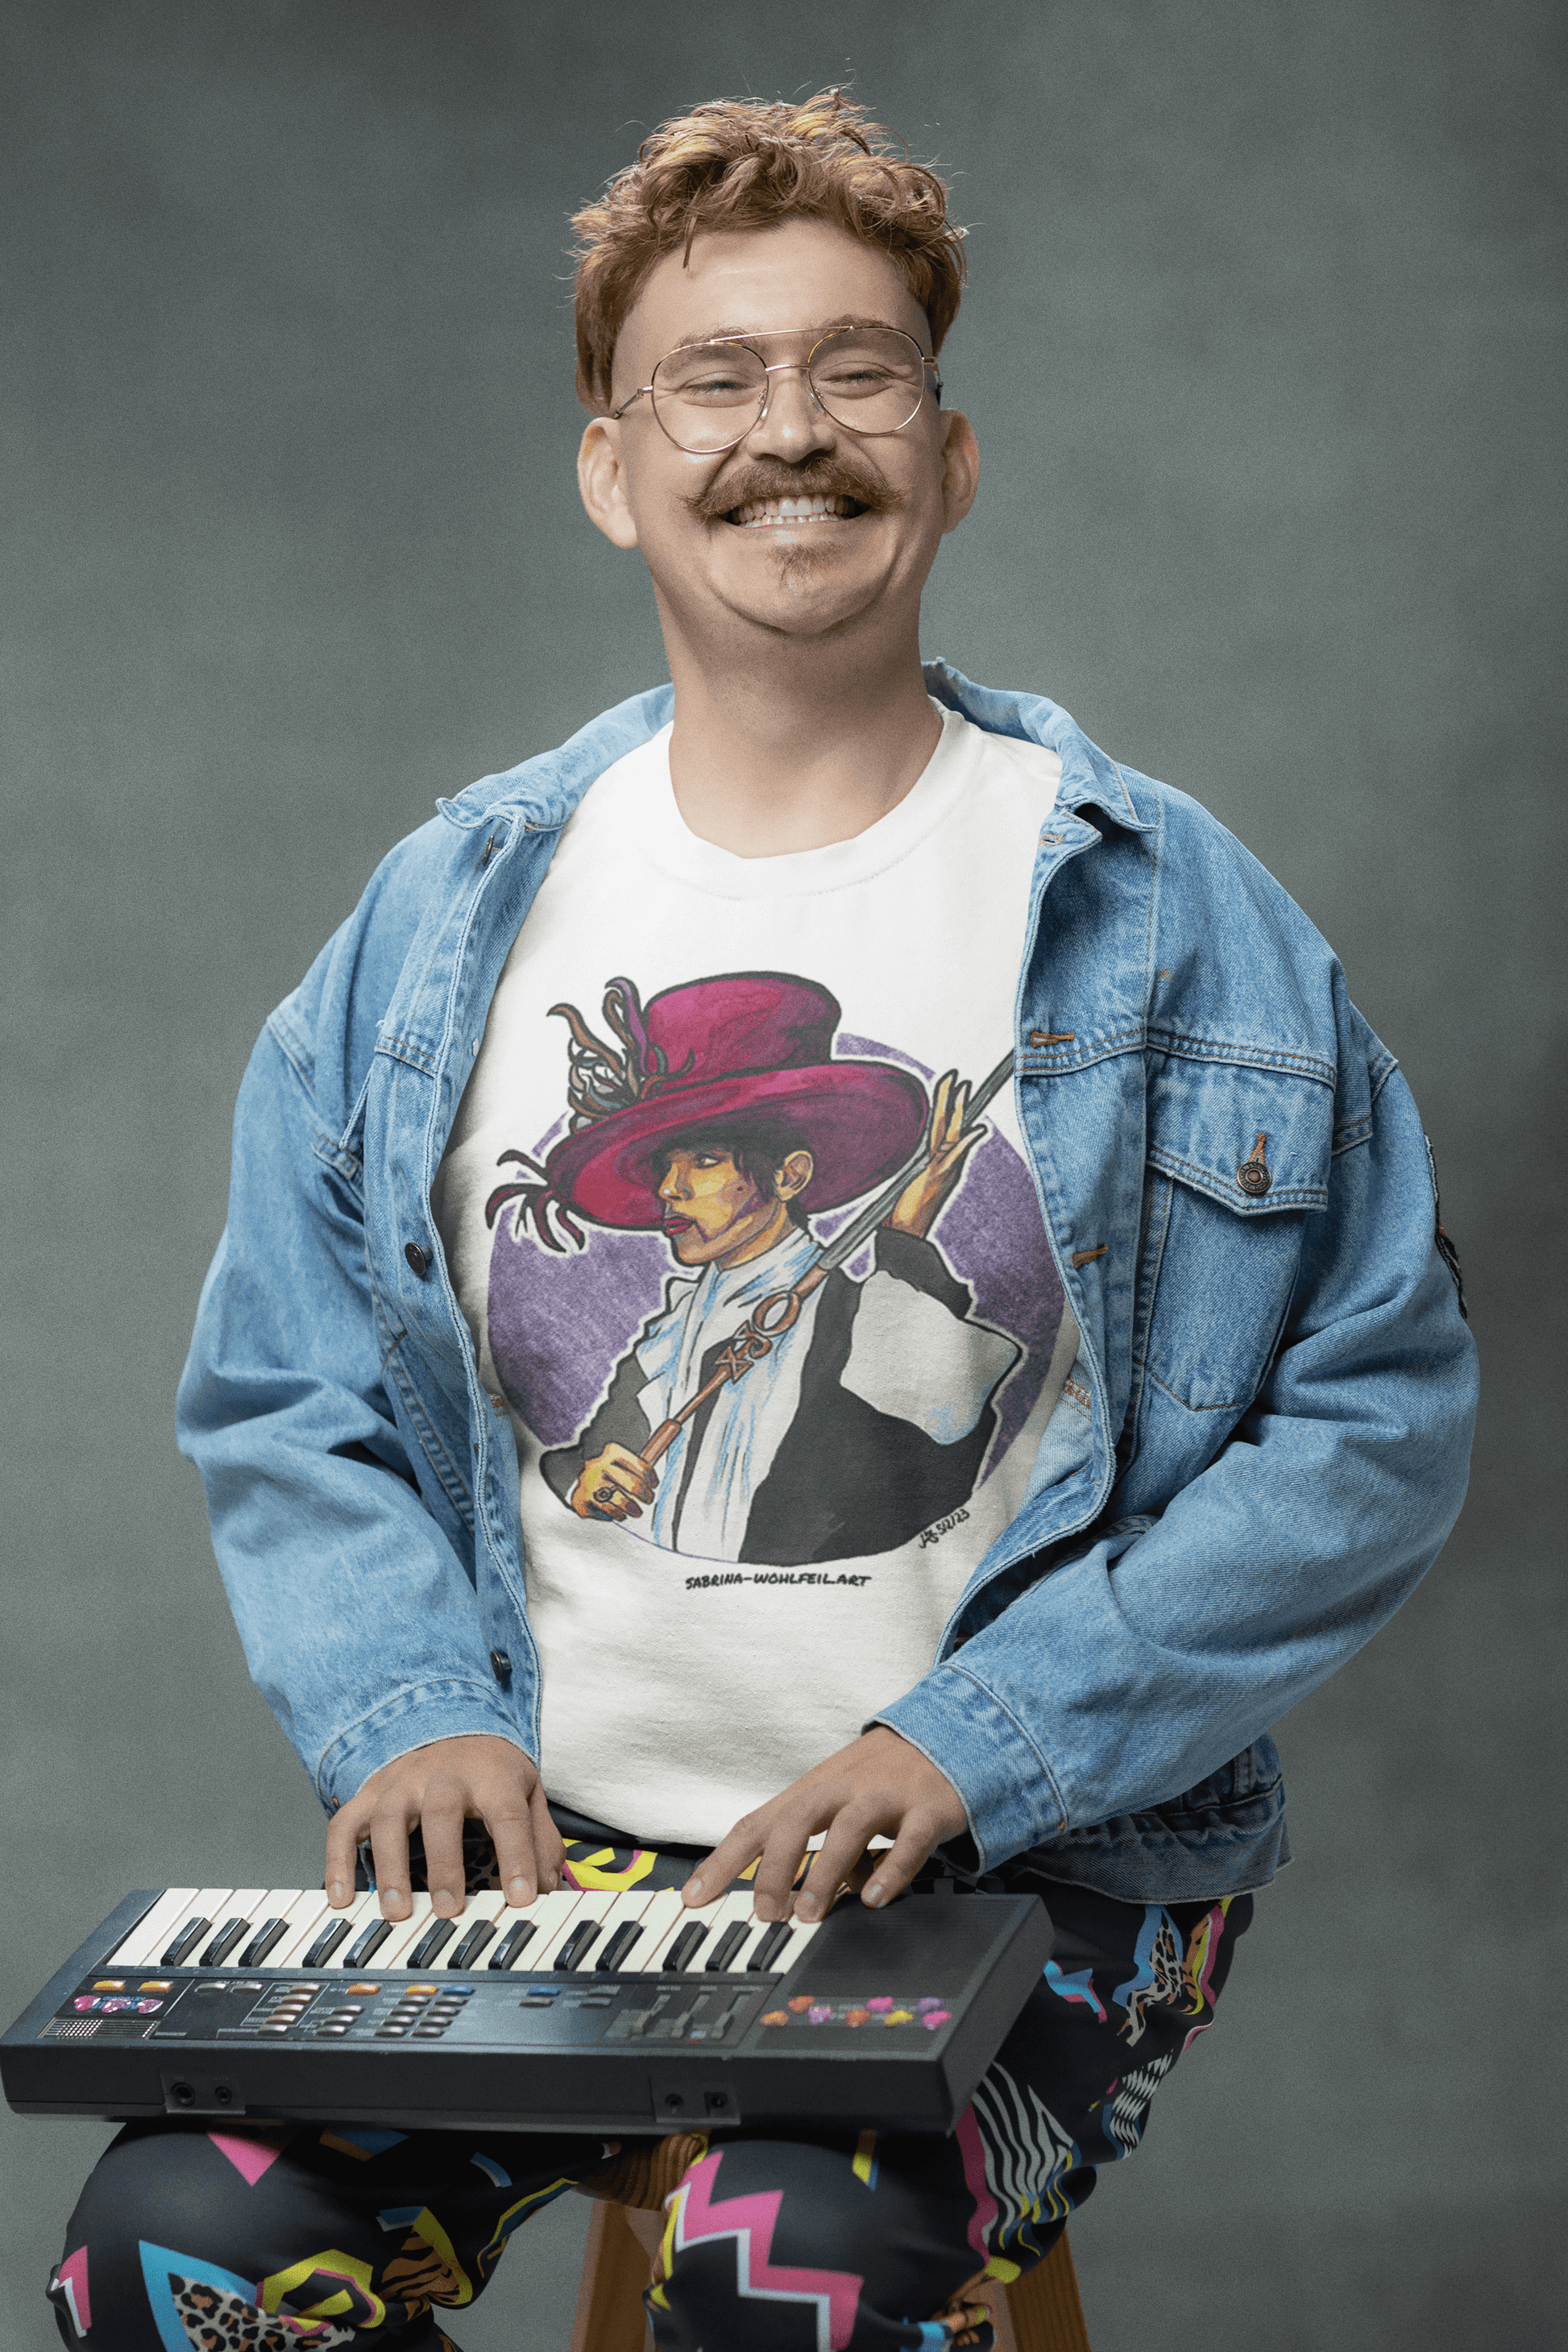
[{"left": 545, "top": 972, "right": 927, "bottom": 1228}]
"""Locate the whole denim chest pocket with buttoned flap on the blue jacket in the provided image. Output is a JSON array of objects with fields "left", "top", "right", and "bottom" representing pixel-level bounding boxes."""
[{"left": 1135, "top": 1054, "right": 1333, "bottom": 1413}]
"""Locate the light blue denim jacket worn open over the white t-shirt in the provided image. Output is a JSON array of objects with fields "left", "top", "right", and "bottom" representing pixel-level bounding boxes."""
[{"left": 179, "top": 663, "right": 1476, "bottom": 1901}]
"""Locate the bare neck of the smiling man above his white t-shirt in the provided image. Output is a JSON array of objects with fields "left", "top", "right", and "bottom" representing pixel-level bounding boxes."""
[{"left": 666, "top": 607, "right": 943, "bottom": 858}]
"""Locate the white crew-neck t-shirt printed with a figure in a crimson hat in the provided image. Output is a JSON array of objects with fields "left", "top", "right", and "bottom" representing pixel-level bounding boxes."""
[{"left": 433, "top": 711, "right": 1076, "bottom": 1844}]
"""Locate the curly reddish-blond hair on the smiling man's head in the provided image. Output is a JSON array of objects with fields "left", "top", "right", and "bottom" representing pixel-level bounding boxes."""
[{"left": 571, "top": 89, "right": 964, "bottom": 414}]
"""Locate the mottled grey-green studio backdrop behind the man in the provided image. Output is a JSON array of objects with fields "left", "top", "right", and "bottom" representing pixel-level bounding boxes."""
[{"left": 0, "top": 0, "right": 1566, "bottom": 2352}]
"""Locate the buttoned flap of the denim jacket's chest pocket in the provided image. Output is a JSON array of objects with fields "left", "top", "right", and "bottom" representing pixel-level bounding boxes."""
[{"left": 1147, "top": 1054, "right": 1333, "bottom": 1216}]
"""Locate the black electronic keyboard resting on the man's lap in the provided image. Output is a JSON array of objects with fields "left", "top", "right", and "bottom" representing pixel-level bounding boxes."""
[{"left": 0, "top": 1886, "right": 1051, "bottom": 2134}]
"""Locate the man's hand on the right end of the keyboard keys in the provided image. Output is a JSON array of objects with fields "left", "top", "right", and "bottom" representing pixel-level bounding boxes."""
[{"left": 682, "top": 1724, "right": 969, "bottom": 1919}]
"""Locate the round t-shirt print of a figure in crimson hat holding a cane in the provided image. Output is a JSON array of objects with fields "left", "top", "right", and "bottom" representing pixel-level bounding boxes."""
[{"left": 484, "top": 972, "right": 1063, "bottom": 1566}]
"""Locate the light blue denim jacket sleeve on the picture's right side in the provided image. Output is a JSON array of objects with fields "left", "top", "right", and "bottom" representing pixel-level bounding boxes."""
[{"left": 879, "top": 1072, "right": 1476, "bottom": 1865}]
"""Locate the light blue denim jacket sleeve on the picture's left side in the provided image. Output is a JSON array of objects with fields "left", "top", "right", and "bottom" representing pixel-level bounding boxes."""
[{"left": 179, "top": 1021, "right": 527, "bottom": 1804}]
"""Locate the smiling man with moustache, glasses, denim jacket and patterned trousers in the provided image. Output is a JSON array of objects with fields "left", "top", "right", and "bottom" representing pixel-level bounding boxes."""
[{"left": 49, "top": 94, "right": 1474, "bottom": 2352}]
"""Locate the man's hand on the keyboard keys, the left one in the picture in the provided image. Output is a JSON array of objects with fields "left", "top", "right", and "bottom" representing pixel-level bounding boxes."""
[{"left": 327, "top": 1731, "right": 566, "bottom": 1919}]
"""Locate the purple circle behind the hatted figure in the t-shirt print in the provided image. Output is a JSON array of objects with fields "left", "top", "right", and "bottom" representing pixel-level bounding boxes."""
[{"left": 489, "top": 1035, "right": 1063, "bottom": 1477}]
